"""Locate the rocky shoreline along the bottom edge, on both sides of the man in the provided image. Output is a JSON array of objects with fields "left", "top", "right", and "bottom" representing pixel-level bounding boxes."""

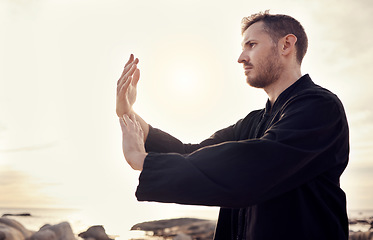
[{"left": 0, "top": 215, "right": 373, "bottom": 240}]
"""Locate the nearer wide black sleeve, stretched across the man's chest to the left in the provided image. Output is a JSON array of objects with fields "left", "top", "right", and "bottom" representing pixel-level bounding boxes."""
[{"left": 136, "top": 94, "right": 348, "bottom": 207}]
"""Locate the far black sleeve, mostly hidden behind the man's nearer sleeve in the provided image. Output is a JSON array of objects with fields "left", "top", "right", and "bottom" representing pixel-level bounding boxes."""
[{"left": 145, "top": 120, "right": 237, "bottom": 154}]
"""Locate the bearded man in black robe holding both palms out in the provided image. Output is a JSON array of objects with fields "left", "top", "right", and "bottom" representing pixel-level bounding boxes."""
[{"left": 117, "top": 12, "right": 349, "bottom": 240}]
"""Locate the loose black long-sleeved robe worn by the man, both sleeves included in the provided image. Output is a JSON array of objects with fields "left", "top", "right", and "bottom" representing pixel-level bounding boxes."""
[{"left": 136, "top": 75, "right": 349, "bottom": 240}]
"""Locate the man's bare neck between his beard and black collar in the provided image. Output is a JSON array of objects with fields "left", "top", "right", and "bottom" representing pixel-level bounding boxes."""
[{"left": 264, "top": 68, "right": 302, "bottom": 106}]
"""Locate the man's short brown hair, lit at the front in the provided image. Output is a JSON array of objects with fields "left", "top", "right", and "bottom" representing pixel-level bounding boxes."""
[{"left": 241, "top": 10, "right": 308, "bottom": 64}]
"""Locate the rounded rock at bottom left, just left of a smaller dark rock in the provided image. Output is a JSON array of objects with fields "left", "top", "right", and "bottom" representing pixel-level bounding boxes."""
[{"left": 30, "top": 222, "right": 76, "bottom": 240}]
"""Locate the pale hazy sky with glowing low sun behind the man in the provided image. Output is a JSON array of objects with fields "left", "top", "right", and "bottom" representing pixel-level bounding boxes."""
[{"left": 0, "top": 0, "right": 373, "bottom": 231}]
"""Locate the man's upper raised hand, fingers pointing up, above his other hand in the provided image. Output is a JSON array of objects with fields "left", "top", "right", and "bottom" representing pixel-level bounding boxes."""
[{"left": 116, "top": 54, "right": 140, "bottom": 117}]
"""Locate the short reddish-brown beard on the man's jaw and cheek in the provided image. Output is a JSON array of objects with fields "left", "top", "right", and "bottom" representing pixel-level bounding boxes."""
[{"left": 246, "top": 47, "right": 283, "bottom": 88}]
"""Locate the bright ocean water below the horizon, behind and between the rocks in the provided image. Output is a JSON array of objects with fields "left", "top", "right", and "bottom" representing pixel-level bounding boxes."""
[{"left": 0, "top": 207, "right": 373, "bottom": 240}]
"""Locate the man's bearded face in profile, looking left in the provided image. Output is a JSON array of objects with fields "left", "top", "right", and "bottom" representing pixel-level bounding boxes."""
[{"left": 238, "top": 22, "right": 283, "bottom": 88}]
